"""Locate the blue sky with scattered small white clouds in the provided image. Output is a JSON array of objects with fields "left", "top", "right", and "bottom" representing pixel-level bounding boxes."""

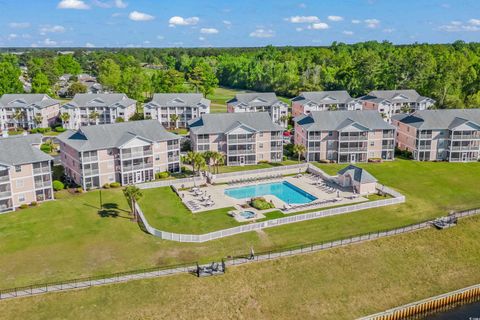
[{"left": 0, "top": 0, "right": 480, "bottom": 47}]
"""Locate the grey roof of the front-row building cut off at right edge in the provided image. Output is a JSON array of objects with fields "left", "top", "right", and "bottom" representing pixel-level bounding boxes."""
[{"left": 392, "top": 109, "right": 480, "bottom": 130}]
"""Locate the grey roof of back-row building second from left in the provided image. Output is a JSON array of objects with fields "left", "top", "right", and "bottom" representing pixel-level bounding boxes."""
[{"left": 62, "top": 93, "right": 137, "bottom": 108}]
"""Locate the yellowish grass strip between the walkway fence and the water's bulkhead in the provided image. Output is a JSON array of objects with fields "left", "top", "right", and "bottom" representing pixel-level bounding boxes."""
[{"left": 0, "top": 217, "right": 480, "bottom": 320}]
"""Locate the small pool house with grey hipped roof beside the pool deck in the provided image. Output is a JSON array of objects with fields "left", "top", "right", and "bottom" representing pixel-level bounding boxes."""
[{"left": 338, "top": 165, "right": 378, "bottom": 194}]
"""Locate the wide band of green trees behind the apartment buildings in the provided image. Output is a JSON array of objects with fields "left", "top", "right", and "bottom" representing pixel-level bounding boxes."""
[{"left": 0, "top": 41, "right": 480, "bottom": 108}]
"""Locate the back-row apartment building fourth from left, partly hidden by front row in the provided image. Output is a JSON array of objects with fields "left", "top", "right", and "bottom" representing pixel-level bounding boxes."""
[{"left": 227, "top": 92, "right": 288, "bottom": 127}]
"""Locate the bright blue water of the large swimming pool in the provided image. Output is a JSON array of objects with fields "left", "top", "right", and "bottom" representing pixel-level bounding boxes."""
[{"left": 225, "top": 181, "right": 317, "bottom": 204}]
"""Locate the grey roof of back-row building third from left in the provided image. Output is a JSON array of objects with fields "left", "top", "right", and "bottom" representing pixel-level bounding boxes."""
[{"left": 145, "top": 93, "right": 210, "bottom": 108}]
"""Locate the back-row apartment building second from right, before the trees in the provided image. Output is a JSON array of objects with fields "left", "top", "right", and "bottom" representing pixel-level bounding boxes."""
[{"left": 292, "top": 90, "right": 362, "bottom": 117}]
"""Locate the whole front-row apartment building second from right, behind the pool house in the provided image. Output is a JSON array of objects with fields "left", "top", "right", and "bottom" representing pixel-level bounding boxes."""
[{"left": 294, "top": 110, "right": 395, "bottom": 163}]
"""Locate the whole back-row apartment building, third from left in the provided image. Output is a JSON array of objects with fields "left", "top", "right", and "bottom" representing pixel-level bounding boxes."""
[{"left": 143, "top": 93, "right": 210, "bottom": 128}]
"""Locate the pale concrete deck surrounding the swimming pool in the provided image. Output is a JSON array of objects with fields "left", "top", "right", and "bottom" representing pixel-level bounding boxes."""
[{"left": 179, "top": 175, "right": 368, "bottom": 215}]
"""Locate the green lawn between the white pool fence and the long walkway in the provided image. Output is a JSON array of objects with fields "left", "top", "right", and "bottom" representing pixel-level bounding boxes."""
[{"left": 0, "top": 160, "right": 480, "bottom": 288}]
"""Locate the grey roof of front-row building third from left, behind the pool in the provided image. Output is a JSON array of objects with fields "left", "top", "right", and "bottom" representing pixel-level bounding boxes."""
[{"left": 188, "top": 112, "right": 284, "bottom": 134}]
